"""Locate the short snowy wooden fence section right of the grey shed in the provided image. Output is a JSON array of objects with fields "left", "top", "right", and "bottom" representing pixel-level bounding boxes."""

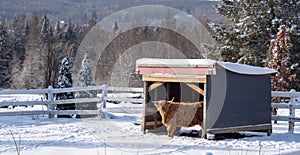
[{"left": 271, "top": 89, "right": 300, "bottom": 132}]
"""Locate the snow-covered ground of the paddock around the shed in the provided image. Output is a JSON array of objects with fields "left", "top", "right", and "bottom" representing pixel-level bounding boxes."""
[{"left": 0, "top": 96, "right": 300, "bottom": 155}]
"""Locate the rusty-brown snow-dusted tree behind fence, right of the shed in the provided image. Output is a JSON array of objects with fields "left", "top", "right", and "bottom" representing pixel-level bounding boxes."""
[{"left": 267, "top": 25, "right": 296, "bottom": 91}]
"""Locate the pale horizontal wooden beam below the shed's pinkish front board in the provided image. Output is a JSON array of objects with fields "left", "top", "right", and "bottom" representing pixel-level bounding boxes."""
[{"left": 143, "top": 75, "right": 206, "bottom": 83}]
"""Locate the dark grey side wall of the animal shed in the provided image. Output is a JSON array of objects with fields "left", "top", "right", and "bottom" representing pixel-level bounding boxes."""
[{"left": 205, "top": 67, "right": 271, "bottom": 130}]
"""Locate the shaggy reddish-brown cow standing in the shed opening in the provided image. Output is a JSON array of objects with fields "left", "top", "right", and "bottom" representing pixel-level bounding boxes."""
[{"left": 154, "top": 100, "right": 204, "bottom": 137}]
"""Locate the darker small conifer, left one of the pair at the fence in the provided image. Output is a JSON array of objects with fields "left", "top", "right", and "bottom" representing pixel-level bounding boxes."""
[{"left": 56, "top": 57, "right": 75, "bottom": 110}]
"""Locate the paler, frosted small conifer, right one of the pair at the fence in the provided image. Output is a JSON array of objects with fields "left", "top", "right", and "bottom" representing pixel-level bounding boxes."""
[{"left": 75, "top": 54, "right": 97, "bottom": 110}]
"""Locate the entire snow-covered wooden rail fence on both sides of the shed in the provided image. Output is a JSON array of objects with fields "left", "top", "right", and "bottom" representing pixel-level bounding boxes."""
[{"left": 0, "top": 85, "right": 300, "bottom": 132}]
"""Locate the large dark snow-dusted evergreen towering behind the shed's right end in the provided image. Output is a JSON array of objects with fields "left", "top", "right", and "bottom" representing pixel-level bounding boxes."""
[{"left": 211, "top": 0, "right": 300, "bottom": 66}]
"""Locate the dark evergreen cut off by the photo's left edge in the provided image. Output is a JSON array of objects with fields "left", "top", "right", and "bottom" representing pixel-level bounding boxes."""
[{"left": 0, "top": 22, "right": 13, "bottom": 88}]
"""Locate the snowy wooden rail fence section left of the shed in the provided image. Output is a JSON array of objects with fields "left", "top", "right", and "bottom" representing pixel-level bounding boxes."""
[{"left": 0, "top": 85, "right": 143, "bottom": 118}]
